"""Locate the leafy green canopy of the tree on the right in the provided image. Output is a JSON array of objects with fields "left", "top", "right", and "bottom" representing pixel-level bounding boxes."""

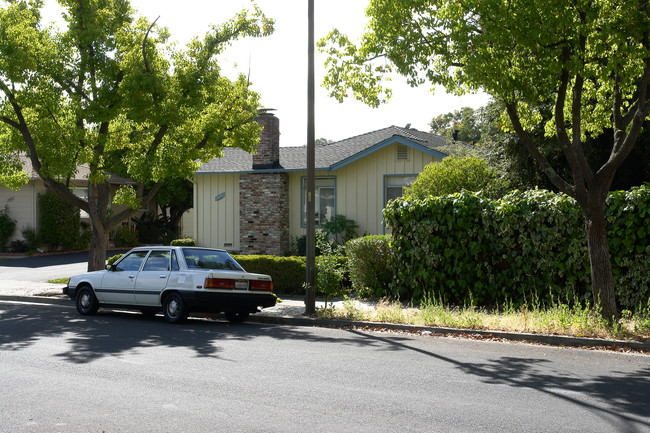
[{"left": 319, "top": 0, "right": 650, "bottom": 140}]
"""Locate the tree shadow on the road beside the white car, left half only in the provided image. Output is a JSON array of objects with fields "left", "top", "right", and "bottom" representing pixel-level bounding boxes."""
[{"left": 0, "top": 304, "right": 404, "bottom": 364}]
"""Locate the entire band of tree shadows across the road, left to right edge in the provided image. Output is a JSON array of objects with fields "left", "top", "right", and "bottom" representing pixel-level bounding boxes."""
[{"left": 0, "top": 303, "right": 650, "bottom": 433}]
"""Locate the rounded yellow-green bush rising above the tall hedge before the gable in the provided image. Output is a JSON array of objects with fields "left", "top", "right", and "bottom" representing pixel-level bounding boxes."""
[{"left": 404, "top": 156, "right": 506, "bottom": 199}]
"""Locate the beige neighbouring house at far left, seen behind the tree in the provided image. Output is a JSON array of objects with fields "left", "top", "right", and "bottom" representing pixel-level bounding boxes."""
[{"left": 0, "top": 156, "right": 134, "bottom": 242}]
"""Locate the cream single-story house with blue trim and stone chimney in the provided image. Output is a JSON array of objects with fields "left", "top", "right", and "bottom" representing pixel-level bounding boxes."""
[{"left": 183, "top": 110, "right": 448, "bottom": 255}]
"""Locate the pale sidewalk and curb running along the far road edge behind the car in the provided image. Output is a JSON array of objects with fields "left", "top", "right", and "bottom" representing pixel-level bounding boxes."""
[{"left": 0, "top": 280, "right": 650, "bottom": 353}]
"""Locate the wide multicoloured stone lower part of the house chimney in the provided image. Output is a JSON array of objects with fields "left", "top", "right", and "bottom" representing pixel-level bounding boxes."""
[{"left": 239, "top": 173, "right": 290, "bottom": 255}]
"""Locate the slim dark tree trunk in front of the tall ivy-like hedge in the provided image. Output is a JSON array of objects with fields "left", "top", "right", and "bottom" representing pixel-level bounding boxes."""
[{"left": 585, "top": 203, "right": 619, "bottom": 320}]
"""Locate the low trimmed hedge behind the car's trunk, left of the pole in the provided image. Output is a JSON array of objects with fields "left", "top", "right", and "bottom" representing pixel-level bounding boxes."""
[{"left": 233, "top": 255, "right": 306, "bottom": 295}]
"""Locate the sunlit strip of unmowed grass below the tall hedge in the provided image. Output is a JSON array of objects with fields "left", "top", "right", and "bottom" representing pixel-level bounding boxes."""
[{"left": 316, "top": 300, "right": 650, "bottom": 341}]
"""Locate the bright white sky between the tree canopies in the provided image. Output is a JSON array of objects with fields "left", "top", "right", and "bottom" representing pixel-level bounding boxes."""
[{"left": 44, "top": 0, "right": 488, "bottom": 146}]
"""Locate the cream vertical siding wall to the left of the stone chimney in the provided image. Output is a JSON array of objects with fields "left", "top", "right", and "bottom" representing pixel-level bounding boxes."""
[{"left": 194, "top": 174, "right": 240, "bottom": 251}]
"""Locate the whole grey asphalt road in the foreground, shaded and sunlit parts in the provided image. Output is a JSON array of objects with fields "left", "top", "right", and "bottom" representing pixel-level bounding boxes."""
[{"left": 0, "top": 302, "right": 650, "bottom": 433}]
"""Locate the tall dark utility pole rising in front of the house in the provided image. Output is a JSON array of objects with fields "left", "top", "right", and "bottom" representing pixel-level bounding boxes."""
[{"left": 305, "top": 0, "right": 316, "bottom": 316}]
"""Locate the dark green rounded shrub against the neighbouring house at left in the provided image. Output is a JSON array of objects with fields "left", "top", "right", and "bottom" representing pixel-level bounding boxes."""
[{"left": 38, "top": 191, "right": 81, "bottom": 251}]
